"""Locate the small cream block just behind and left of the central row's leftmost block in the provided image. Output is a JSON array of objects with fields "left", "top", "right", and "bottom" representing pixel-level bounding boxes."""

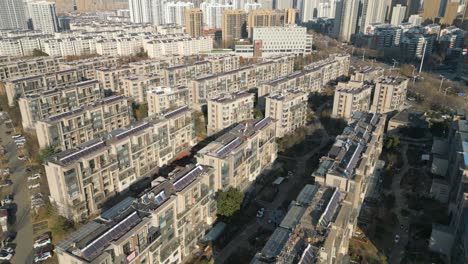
[{"left": 121, "top": 74, "right": 163, "bottom": 103}]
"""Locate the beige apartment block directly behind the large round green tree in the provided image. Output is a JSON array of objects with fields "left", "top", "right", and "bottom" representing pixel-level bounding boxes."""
[{"left": 196, "top": 117, "right": 277, "bottom": 191}]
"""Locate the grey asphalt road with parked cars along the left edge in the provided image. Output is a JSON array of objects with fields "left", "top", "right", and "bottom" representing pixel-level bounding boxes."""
[{"left": 0, "top": 124, "right": 34, "bottom": 264}]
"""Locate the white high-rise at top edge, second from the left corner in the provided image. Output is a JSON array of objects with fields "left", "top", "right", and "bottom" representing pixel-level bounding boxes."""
[{"left": 30, "top": 1, "right": 59, "bottom": 33}]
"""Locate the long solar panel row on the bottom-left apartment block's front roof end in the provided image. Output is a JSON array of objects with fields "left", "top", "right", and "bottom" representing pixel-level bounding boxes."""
[{"left": 81, "top": 211, "right": 141, "bottom": 259}]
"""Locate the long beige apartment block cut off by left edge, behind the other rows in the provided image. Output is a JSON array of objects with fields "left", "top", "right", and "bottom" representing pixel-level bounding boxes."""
[{"left": 0, "top": 57, "right": 64, "bottom": 81}]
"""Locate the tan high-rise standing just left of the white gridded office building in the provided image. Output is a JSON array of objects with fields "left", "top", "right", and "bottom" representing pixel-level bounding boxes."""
[{"left": 222, "top": 10, "right": 247, "bottom": 47}]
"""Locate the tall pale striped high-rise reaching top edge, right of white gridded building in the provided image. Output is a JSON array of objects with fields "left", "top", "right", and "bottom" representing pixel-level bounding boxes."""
[{"left": 333, "top": 0, "right": 361, "bottom": 42}]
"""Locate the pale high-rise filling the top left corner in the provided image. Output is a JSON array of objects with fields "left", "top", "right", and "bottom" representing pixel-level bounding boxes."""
[{"left": 0, "top": 0, "right": 28, "bottom": 29}]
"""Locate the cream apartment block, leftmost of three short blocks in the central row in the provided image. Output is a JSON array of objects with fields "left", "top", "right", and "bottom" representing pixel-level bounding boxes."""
[{"left": 147, "top": 85, "right": 192, "bottom": 116}]
